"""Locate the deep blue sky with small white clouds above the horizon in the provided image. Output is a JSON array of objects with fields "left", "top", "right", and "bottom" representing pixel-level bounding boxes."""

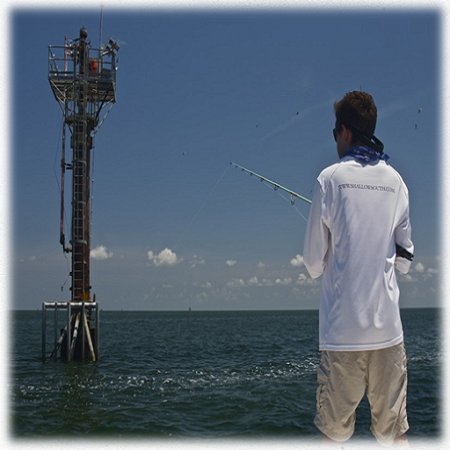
[{"left": 2, "top": 1, "right": 444, "bottom": 311}]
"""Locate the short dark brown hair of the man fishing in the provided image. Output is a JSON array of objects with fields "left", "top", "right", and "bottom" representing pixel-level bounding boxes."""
[{"left": 334, "top": 91, "right": 377, "bottom": 141}]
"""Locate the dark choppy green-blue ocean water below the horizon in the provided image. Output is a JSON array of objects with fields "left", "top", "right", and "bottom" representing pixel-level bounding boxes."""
[{"left": 8, "top": 309, "right": 443, "bottom": 442}]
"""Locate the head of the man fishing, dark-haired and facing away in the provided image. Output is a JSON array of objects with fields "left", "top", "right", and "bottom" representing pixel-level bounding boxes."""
[{"left": 334, "top": 91, "right": 377, "bottom": 158}]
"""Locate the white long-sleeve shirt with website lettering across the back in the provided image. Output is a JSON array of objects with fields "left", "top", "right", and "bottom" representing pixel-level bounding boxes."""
[{"left": 303, "top": 156, "right": 414, "bottom": 351}]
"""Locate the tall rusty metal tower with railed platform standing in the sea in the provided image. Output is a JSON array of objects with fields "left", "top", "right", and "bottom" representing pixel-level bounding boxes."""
[{"left": 42, "top": 27, "right": 119, "bottom": 360}]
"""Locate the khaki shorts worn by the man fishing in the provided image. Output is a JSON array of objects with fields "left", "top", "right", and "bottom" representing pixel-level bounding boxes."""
[{"left": 314, "top": 343, "right": 409, "bottom": 445}]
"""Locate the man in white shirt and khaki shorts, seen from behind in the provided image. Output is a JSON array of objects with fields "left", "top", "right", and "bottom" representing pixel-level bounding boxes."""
[{"left": 303, "top": 91, "right": 414, "bottom": 445}]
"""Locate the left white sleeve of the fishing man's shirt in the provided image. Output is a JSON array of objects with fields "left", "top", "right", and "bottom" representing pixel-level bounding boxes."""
[{"left": 303, "top": 180, "right": 329, "bottom": 278}]
